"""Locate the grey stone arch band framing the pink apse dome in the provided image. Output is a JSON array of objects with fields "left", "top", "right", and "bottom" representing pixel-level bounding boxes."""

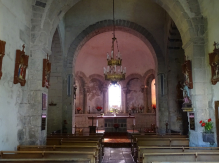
[{"left": 67, "top": 20, "right": 164, "bottom": 69}]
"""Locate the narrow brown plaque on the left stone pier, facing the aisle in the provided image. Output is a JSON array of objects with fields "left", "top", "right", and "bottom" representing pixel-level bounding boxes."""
[{"left": 42, "top": 54, "right": 51, "bottom": 88}]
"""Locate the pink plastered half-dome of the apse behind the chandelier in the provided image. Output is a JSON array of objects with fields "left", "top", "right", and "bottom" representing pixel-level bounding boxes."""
[{"left": 75, "top": 31, "right": 155, "bottom": 77}]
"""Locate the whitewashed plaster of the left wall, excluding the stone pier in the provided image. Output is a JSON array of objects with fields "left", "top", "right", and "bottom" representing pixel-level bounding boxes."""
[{"left": 0, "top": 0, "right": 32, "bottom": 150}]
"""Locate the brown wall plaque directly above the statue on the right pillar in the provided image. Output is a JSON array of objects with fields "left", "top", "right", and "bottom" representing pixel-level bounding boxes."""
[{"left": 182, "top": 60, "right": 193, "bottom": 89}]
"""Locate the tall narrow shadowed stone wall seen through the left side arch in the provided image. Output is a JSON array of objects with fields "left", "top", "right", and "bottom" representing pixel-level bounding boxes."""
[{"left": 47, "top": 30, "right": 63, "bottom": 134}]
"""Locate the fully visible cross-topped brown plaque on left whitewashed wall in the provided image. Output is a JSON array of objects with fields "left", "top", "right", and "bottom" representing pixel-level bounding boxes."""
[{"left": 14, "top": 45, "right": 29, "bottom": 86}]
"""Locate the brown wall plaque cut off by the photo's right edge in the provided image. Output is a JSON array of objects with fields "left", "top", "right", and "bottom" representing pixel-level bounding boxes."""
[{"left": 209, "top": 42, "right": 219, "bottom": 85}]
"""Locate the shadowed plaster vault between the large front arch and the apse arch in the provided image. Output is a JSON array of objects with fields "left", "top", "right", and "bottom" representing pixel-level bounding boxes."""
[{"left": 64, "top": 0, "right": 166, "bottom": 54}]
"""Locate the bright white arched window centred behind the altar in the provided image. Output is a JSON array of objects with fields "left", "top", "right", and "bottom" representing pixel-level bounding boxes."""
[{"left": 108, "top": 84, "right": 121, "bottom": 109}]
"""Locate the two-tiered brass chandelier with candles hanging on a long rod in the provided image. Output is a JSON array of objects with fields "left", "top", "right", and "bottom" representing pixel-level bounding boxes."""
[{"left": 103, "top": 0, "right": 126, "bottom": 84}]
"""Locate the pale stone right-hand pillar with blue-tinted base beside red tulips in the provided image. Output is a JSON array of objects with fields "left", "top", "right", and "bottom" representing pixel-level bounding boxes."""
[{"left": 183, "top": 38, "right": 210, "bottom": 146}]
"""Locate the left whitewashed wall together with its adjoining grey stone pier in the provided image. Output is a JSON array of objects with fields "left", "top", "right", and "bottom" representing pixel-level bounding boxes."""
[{"left": 0, "top": 0, "right": 46, "bottom": 150}]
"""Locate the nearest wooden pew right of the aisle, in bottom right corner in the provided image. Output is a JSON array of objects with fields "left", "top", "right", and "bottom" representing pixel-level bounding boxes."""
[{"left": 143, "top": 152, "right": 219, "bottom": 163}]
